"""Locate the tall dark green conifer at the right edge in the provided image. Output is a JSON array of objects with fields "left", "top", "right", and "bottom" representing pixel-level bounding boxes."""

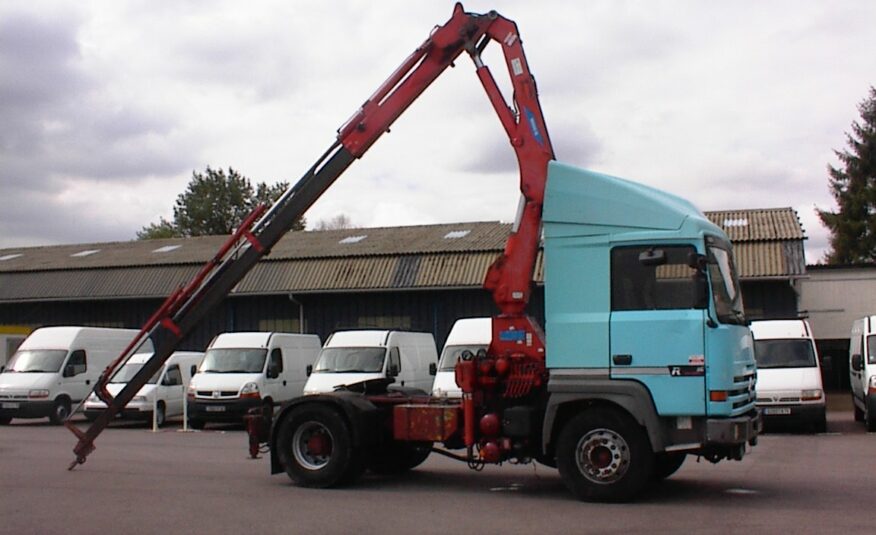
[{"left": 818, "top": 86, "right": 876, "bottom": 264}]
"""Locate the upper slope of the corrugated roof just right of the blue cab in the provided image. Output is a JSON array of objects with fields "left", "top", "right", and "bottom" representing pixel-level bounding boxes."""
[{"left": 705, "top": 208, "right": 806, "bottom": 243}]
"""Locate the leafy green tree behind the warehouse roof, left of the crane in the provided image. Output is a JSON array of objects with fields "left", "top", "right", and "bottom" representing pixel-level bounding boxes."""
[{"left": 137, "top": 166, "right": 305, "bottom": 240}]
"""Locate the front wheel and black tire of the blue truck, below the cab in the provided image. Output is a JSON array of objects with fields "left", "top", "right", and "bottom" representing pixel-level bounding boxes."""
[{"left": 557, "top": 409, "right": 654, "bottom": 502}]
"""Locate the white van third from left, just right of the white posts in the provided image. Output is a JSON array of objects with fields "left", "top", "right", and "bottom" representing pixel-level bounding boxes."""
[{"left": 188, "top": 332, "right": 320, "bottom": 429}]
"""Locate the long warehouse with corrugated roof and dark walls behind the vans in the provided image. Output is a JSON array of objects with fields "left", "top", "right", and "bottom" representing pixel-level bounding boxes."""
[{"left": 0, "top": 208, "right": 805, "bottom": 349}]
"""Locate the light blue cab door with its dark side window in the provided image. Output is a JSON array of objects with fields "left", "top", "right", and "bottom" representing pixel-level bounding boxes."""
[{"left": 609, "top": 244, "right": 706, "bottom": 415}]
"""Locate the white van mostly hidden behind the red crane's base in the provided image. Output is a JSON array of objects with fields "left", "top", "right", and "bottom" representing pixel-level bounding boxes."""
[{"left": 432, "top": 318, "right": 493, "bottom": 398}]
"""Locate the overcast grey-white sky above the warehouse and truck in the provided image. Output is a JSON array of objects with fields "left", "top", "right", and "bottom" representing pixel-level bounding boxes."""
[{"left": 0, "top": 0, "right": 876, "bottom": 263}]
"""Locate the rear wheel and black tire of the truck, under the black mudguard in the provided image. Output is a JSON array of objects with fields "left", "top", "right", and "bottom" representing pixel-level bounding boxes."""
[{"left": 277, "top": 405, "right": 365, "bottom": 488}]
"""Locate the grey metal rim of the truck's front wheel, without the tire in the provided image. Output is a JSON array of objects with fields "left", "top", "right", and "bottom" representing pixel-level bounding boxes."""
[{"left": 575, "top": 429, "right": 630, "bottom": 484}]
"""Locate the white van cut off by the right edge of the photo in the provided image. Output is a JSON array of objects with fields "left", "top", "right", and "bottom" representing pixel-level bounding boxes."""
[{"left": 849, "top": 316, "right": 876, "bottom": 431}]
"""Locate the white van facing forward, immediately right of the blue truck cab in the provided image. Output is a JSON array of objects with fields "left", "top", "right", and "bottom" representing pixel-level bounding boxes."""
[{"left": 751, "top": 319, "right": 827, "bottom": 433}]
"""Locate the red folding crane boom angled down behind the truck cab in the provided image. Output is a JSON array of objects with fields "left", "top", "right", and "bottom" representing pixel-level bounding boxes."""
[{"left": 66, "top": 4, "right": 554, "bottom": 470}]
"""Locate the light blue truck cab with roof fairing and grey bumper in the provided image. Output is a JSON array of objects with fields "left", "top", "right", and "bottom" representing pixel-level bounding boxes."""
[{"left": 543, "top": 162, "right": 760, "bottom": 490}]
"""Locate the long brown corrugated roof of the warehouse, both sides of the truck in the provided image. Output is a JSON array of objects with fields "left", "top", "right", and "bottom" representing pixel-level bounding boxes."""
[{"left": 0, "top": 208, "right": 805, "bottom": 302}]
